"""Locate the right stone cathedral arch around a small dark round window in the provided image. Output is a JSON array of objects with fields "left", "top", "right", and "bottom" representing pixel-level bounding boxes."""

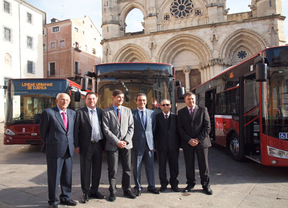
[{"left": 219, "top": 29, "right": 268, "bottom": 65}]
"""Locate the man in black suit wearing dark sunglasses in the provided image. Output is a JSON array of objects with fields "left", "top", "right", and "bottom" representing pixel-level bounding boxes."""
[{"left": 154, "top": 99, "right": 180, "bottom": 192}]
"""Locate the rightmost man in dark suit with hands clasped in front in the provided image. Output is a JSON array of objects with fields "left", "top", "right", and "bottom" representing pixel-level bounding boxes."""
[{"left": 178, "top": 92, "right": 213, "bottom": 195}]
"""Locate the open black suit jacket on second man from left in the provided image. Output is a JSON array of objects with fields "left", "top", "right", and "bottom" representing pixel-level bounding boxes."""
[{"left": 74, "top": 107, "right": 105, "bottom": 155}]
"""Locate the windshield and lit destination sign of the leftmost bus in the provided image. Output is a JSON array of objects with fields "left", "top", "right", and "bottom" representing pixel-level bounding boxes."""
[{"left": 5, "top": 79, "right": 68, "bottom": 125}]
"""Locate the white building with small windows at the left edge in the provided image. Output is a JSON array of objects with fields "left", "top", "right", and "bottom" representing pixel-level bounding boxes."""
[{"left": 0, "top": 0, "right": 46, "bottom": 122}]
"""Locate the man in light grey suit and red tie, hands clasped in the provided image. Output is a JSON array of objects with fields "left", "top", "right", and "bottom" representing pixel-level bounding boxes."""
[{"left": 103, "top": 90, "right": 136, "bottom": 202}]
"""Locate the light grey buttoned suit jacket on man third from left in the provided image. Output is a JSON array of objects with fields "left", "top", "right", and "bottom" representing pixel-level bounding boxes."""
[{"left": 102, "top": 106, "right": 134, "bottom": 151}]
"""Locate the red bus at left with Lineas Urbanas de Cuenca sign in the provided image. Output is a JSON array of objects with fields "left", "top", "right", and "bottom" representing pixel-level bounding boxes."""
[{"left": 4, "top": 79, "right": 85, "bottom": 145}]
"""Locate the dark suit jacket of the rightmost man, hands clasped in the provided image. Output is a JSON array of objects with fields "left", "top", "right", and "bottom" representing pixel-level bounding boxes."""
[{"left": 177, "top": 105, "right": 211, "bottom": 150}]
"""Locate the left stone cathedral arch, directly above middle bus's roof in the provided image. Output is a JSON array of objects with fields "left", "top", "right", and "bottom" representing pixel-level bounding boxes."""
[{"left": 112, "top": 44, "right": 149, "bottom": 62}]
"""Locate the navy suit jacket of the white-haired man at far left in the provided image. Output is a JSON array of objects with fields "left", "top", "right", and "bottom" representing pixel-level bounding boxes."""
[{"left": 39, "top": 107, "right": 76, "bottom": 157}]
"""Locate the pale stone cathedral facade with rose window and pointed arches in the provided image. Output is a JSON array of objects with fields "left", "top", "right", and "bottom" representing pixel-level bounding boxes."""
[{"left": 102, "top": 0, "right": 286, "bottom": 91}]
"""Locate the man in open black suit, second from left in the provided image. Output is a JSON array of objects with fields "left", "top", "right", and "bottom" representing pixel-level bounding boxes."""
[{"left": 74, "top": 92, "right": 105, "bottom": 203}]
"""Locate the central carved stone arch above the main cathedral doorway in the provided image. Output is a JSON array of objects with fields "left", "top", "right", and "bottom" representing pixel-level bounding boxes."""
[{"left": 157, "top": 34, "right": 212, "bottom": 68}]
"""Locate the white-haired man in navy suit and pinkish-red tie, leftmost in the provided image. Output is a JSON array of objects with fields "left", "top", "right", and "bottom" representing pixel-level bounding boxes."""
[{"left": 39, "top": 93, "right": 77, "bottom": 207}]
